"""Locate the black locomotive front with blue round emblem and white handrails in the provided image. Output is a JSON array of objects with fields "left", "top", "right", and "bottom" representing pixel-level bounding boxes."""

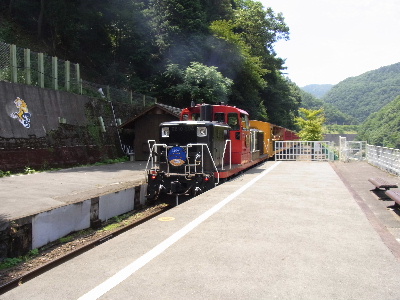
[{"left": 147, "top": 121, "right": 230, "bottom": 199}]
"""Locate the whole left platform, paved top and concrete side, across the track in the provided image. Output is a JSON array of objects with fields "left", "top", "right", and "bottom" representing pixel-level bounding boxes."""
[{"left": 0, "top": 161, "right": 146, "bottom": 252}]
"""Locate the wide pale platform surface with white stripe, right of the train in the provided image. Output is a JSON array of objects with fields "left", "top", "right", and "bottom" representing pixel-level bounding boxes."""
[{"left": 0, "top": 162, "right": 400, "bottom": 300}]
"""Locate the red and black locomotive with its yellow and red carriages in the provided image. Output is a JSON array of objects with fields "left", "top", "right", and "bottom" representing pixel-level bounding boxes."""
[{"left": 146, "top": 103, "right": 298, "bottom": 200}]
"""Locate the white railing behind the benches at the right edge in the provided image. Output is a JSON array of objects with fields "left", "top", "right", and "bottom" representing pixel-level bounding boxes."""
[{"left": 367, "top": 145, "right": 400, "bottom": 176}]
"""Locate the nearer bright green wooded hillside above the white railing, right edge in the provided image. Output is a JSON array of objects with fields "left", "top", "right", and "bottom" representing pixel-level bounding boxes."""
[{"left": 358, "top": 96, "right": 400, "bottom": 149}]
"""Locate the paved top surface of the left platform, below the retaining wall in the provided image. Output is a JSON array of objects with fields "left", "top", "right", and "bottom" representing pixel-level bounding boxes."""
[{"left": 0, "top": 161, "right": 146, "bottom": 220}]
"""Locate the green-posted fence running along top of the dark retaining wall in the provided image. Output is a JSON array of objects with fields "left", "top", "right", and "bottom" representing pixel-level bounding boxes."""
[{"left": 0, "top": 42, "right": 156, "bottom": 107}]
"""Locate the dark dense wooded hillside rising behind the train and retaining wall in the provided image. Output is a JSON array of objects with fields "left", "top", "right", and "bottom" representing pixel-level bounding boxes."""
[{"left": 0, "top": 0, "right": 300, "bottom": 128}]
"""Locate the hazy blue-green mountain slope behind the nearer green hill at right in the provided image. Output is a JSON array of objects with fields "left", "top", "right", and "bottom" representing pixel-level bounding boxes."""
[{"left": 323, "top": 63, "right": 400, "bottom": 122}]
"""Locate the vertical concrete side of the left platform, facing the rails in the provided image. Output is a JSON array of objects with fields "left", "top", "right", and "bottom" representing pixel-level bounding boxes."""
[{"left": 0, "top": 186, "right": 145, "bottom": 258}]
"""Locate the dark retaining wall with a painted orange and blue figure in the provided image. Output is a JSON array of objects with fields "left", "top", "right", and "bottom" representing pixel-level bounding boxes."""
[{"left": 0, "top": 81, "right": 143, "bottom": 172}]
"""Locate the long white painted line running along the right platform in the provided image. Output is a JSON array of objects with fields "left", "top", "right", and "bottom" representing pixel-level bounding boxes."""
[{"left": 78, "top": 161, "right": 281, "bottom": 300}]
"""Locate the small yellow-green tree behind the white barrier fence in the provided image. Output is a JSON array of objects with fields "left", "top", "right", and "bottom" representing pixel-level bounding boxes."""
[{"left": 295, "top": 108, "right": 325, "bottom": 141}]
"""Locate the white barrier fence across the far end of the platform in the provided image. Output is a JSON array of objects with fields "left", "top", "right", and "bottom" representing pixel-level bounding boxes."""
[{"left": 275, "top": 141, "right": 334, "bottom": 161}]
